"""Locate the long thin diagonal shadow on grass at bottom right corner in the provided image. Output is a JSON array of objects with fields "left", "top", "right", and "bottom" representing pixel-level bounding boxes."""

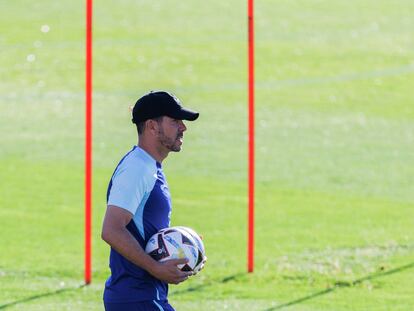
[{"left": 264, "top": 262, "right": 414, "bottom": 311}]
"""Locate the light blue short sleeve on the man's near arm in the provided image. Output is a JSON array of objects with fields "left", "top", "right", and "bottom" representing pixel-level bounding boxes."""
[{"left": 108, "top": 167, "right": 149, "bottom": 215}]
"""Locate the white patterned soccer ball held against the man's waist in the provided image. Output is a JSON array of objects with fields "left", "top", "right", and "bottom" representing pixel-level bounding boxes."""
[{"left": 145, "top": 227, "right": 204, "bottom": 273}]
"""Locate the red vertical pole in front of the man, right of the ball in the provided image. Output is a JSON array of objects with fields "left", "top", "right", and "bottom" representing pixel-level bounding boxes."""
[{"left": 247, "top": 0, "right": 254, "bottom": 273}]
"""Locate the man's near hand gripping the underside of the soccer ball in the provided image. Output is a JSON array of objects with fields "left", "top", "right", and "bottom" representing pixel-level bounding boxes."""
[{"left": 149, "top": 258, "right": 193, "bottom": 284}]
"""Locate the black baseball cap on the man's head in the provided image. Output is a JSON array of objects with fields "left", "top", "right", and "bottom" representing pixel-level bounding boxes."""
[{"left": 132, "top": 91, "right": 199, "bottom": 123}]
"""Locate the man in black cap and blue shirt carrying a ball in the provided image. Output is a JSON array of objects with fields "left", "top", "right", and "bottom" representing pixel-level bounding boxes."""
[{"left": 102, "top": 91, "right": 199, "bottom": 311}]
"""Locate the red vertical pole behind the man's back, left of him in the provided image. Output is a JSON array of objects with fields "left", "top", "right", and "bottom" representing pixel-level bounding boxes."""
[{"left": 85, "top": 0, "right": 92, "bottom": 284}]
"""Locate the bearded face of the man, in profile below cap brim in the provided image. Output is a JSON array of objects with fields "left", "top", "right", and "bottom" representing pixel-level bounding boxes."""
[{"left": 157, "top": 116, "right": 187, "bottom": 152}]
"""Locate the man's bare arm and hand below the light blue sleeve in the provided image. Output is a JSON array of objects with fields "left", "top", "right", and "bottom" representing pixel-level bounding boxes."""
[{"left": 101, "top": 205, "right": 192, "bottom": 284}]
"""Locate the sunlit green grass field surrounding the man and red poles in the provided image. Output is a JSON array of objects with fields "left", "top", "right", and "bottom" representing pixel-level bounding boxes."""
[{"left": 0, "top": 0, "right": 414, "bottom": 311}]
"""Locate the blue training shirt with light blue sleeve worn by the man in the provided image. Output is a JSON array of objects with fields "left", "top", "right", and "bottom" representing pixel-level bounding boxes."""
[{"left": 104, "top": 146, "right": 171, "bottom": 303}]
